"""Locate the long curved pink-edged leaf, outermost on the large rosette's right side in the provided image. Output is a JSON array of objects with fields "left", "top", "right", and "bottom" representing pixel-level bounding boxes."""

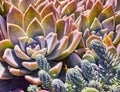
[{"left": 57, "top": 30, "right": 82, "bottom": 59}]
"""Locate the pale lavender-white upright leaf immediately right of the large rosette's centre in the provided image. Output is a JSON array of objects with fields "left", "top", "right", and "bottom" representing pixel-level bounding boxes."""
[{"left": 46, "top": 33, "right": 58, "bottom": 54}]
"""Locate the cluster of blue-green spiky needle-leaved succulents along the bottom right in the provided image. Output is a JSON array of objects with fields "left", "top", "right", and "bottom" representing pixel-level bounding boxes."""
[{"left": 28, "top": 40, "right": 120, "bottom": 92}]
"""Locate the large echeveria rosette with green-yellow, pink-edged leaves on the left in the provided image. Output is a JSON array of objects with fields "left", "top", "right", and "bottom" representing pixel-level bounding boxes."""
[{"left": 0, "top": 5, "right": 81, "bottom": 83}]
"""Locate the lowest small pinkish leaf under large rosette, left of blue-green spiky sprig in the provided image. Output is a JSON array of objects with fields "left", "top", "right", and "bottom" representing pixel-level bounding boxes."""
[{"left": 25, "top": 75, "right": 41, "bottom": 85}]
